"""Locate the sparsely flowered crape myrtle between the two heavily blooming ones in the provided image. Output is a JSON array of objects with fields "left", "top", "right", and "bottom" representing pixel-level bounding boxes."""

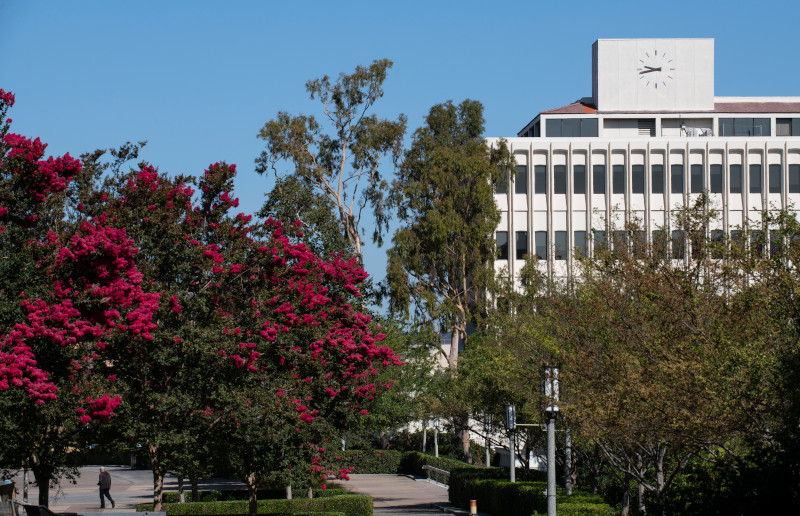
[{"left": 82, "top": 158, "right": 264, "bottom": 510}]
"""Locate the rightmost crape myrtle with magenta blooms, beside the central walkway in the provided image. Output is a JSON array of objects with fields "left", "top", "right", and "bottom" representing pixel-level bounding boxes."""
[{"left": 207, "top": 215, "right": 401, "bottom": 514}]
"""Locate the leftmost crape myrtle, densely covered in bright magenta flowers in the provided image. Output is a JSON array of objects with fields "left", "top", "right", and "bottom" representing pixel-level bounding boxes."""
[{"left": 0, "top": 90, "right": 159, "bottom": 505}]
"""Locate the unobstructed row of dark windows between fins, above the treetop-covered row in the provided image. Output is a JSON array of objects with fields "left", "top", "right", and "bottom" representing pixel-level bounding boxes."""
[{"left": 497, "top": 165, "right": 800, "bottom": 195}]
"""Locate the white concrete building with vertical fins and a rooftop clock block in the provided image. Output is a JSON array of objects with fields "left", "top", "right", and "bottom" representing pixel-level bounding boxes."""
[{"left": 488, "top": 39, "right": 800, "bottom": 278}]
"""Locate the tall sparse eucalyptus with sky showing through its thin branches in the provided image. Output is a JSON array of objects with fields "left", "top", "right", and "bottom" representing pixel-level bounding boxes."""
[{"left": 256, "top": 59, "right": 406, "bottom": 266}]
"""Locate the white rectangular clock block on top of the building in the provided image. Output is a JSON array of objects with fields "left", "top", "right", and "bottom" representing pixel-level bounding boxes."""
[{"left": 592, "top": 39, "right": 714, "bottom": 112}]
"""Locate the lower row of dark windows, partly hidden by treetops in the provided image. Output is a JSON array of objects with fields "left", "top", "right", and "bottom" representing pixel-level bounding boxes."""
[{"left": 496, "top": 229, "right": 782, "bottom": 260}]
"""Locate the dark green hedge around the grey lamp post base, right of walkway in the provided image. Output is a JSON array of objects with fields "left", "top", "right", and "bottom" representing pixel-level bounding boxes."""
[{"left": 449, "top": 468, "right": 616, "bottom": 516}]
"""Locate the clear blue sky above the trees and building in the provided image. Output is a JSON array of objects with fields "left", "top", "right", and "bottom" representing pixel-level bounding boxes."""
[{"left": 0, "top": 0, "right": 800, "bottom": 292}]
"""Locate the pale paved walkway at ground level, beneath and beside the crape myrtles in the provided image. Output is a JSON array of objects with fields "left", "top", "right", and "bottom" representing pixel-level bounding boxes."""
[{"left": 6, "top": 466, "right": 488, "bottom": 516}]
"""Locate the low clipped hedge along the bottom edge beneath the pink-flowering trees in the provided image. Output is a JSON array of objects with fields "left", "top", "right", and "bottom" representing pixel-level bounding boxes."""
[{"left": 136, "top": 495, "right": 372, "bottom": 516}]
